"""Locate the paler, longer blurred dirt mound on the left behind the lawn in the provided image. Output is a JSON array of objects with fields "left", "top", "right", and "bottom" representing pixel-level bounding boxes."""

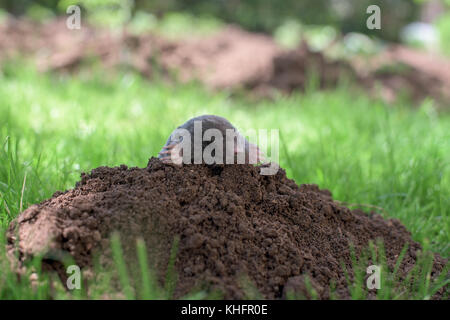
[{"left": 0, "top": 19, "right": 280, "bottom": 88}]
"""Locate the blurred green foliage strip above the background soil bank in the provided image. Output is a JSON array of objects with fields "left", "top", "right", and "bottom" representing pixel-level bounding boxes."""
[{"left": 0, "top": 0, "right": 450, "bottom": 43}]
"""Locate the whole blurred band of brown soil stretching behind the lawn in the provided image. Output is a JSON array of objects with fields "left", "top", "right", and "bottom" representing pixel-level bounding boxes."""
[{"left": 0, "top": 18, "right": 450, "bottom": 106}]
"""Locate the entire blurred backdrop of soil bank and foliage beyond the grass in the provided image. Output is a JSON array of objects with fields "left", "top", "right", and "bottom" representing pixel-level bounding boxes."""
[{"left": 0, "top": 0, "right": 450, "bottom": 106}]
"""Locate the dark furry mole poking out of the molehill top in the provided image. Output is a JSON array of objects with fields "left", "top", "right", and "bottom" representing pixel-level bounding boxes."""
[{"left": 158, "top": 115, "right": 265, "bottom": 165}]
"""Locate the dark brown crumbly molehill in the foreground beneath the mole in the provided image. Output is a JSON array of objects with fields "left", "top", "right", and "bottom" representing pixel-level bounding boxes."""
[{"left": 8, "top": 158, "right": 445, "bottom": 299}]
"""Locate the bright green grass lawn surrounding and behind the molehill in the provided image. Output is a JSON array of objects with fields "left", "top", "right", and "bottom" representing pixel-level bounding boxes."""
[{"left": 0, "top": 65, "right": 450, "bottom": 298}]
